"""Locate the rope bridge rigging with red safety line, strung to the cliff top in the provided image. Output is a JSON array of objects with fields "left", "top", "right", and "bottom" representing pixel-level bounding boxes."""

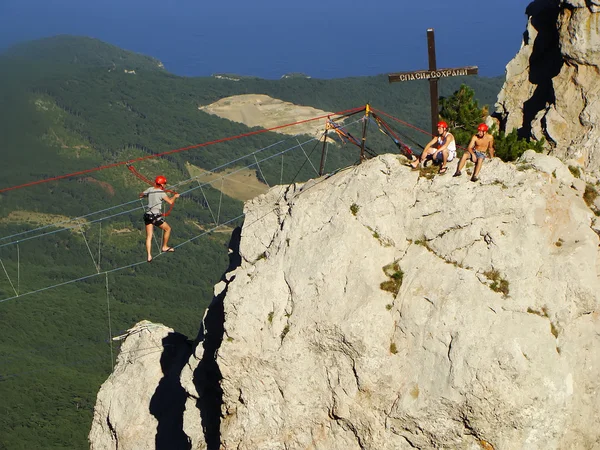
[{"left": 0, "top": 107, "right": 440, "bottom": 381}]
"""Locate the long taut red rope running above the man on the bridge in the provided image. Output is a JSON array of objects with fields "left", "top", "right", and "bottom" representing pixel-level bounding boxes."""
[{"left": 0, "top": 106, "right": 364, "bottom": 194}]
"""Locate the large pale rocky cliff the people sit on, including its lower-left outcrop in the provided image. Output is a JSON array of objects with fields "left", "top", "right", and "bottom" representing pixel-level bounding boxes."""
[{"left": 90, "top": 152, "right": 600, "bottom": 450}]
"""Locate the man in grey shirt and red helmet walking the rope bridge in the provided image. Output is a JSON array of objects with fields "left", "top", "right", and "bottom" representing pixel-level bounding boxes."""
[{"left": 140, "top": 175, "right": 179, "bottom": 262}]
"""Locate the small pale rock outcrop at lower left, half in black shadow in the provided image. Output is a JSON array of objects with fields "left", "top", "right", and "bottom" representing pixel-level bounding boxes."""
[{"left": 89, "top": 321, "right": 191, "bottom": 450}]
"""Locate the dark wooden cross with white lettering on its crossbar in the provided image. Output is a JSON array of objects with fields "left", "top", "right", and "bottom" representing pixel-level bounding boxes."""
[{"left": 388, "top": 28, "right": 478, "bottom": 136}]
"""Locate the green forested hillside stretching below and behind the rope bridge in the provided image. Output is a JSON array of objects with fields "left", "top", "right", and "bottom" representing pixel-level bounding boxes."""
[{"left": 0, "top": 36, "right": 503, "bottom": 450}]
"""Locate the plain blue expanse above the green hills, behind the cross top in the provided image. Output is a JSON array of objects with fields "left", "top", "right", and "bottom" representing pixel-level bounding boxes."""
[{"left": 0, "top": 0, "right": 531, "bottom": 78}]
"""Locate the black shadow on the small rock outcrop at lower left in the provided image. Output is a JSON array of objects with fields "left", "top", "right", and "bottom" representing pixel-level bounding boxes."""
[{"left": 150, "top": 333, "right": 192, "bottom": 450}]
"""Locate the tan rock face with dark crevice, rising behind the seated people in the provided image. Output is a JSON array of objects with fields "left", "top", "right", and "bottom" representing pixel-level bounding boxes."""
[{"left": 496, "top": 0, "right": 600, "bottom": 176}]
